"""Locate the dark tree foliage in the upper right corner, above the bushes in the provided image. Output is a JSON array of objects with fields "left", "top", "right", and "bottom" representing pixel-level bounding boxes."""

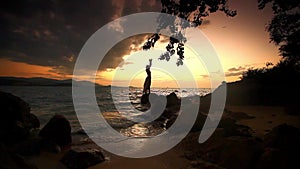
[{"left": 258, "top": 0, "right": 300, "bottom": 68}]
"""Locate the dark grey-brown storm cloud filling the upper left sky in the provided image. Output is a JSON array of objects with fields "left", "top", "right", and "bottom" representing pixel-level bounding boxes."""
[{"left": 0, "top": 0, "right": 160, "bottom": 74}]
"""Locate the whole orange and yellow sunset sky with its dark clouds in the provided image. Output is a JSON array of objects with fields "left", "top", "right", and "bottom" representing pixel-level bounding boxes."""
[{"left": 0, "top": 0, "right": 280, "bottom": 87}]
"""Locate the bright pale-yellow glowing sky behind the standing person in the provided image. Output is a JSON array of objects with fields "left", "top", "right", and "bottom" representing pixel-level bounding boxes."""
[{"left": 96, "top": 33, "right": 216, "bottom": 88}]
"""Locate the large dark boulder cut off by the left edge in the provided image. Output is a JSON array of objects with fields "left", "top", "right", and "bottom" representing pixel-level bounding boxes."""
[{"left": 0, "top": 92, "right": 40, "bottom": 144}]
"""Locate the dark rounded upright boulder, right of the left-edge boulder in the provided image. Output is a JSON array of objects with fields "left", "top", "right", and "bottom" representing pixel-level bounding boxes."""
[{"left": 39, "top": 115, "right": 72, "bottom": 147}]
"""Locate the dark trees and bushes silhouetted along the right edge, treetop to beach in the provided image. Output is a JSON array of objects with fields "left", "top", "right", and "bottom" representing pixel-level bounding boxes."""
[{"left": 237, "top": 0, "right": 300, "bottom": 114}]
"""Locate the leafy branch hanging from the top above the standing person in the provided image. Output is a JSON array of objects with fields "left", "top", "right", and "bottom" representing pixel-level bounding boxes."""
[{"left": 143, "top": 0, "right": 237, "bottom": 66}]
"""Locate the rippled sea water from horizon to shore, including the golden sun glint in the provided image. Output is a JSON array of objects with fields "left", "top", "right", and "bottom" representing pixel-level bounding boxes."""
[{"left": 0, "top": 86, "right": 210, "bottom": 137}]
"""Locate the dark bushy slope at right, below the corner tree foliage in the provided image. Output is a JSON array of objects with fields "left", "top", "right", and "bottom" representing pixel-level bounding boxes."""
[{"left": 242, "top": 59, "right": 300, "bottom": 115}]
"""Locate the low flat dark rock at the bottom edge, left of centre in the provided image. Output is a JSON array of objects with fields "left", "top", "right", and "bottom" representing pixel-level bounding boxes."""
[{"left": 60, "top": 148, "right": 105, "bottom": 169}]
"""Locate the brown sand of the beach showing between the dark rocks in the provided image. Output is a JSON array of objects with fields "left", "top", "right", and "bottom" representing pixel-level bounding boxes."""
[{"left": 34, "top": 106, "right": 300, "bottom": 169}]
